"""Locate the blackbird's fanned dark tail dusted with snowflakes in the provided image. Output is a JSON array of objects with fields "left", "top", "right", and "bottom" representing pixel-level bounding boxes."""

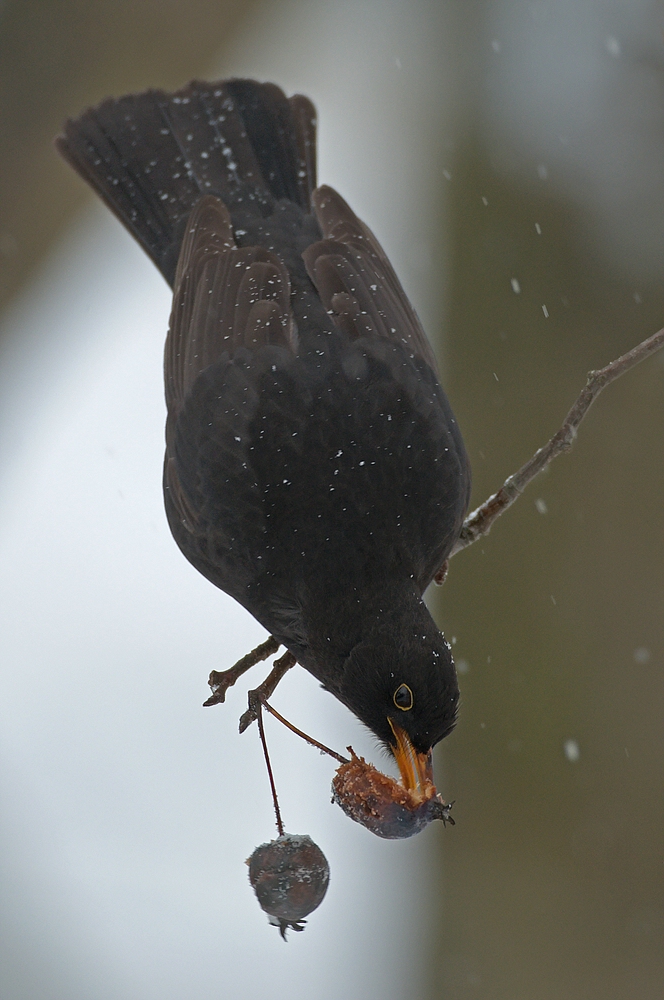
[{"left": 56, "top": 80, "right": 316, "bottom": 286}]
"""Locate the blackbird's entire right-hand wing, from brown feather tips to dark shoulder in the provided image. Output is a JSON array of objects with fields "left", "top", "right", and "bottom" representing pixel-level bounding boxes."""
[{"left": 302, "top": 187, "right": 470, "bottom": 590}]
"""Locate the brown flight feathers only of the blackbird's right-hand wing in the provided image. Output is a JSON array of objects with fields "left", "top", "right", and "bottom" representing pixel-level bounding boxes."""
[{"left": 302, "top": 186, "right": 437, "bottom": 372}]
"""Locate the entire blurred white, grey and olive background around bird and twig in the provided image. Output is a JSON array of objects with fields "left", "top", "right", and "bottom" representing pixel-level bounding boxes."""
[{"left": 0, "top": 0, "right": 664, "bottom": 1000}]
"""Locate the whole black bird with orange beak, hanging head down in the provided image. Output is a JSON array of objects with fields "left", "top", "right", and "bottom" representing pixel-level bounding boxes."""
[{"left": 56, "top": 80, "right": 470, "bottom": 789}]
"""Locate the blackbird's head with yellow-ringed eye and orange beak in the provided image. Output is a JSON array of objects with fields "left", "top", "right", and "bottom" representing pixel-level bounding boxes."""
[{"left": 342, "top": 622, "right": 459, "bottom": 794}]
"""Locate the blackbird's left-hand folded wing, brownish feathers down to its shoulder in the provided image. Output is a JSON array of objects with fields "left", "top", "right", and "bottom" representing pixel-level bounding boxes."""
[{"left": 164, "top": 195, "right": 293, "bottom": 575}]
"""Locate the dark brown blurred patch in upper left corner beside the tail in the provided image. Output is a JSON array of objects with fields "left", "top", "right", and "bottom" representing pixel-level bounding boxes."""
[{"left": 0, "top": 0, "right": 256, "bottom": 309}]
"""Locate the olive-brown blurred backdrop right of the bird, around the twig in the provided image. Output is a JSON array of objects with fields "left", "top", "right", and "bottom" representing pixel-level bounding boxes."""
[{"left": 429, "top": 141, "right": 664, "bottom": 1000}]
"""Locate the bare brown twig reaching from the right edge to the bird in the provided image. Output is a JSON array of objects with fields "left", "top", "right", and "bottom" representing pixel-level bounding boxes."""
[{"left": 452, "top": 329, "right": 664, "bottom": 556}]
